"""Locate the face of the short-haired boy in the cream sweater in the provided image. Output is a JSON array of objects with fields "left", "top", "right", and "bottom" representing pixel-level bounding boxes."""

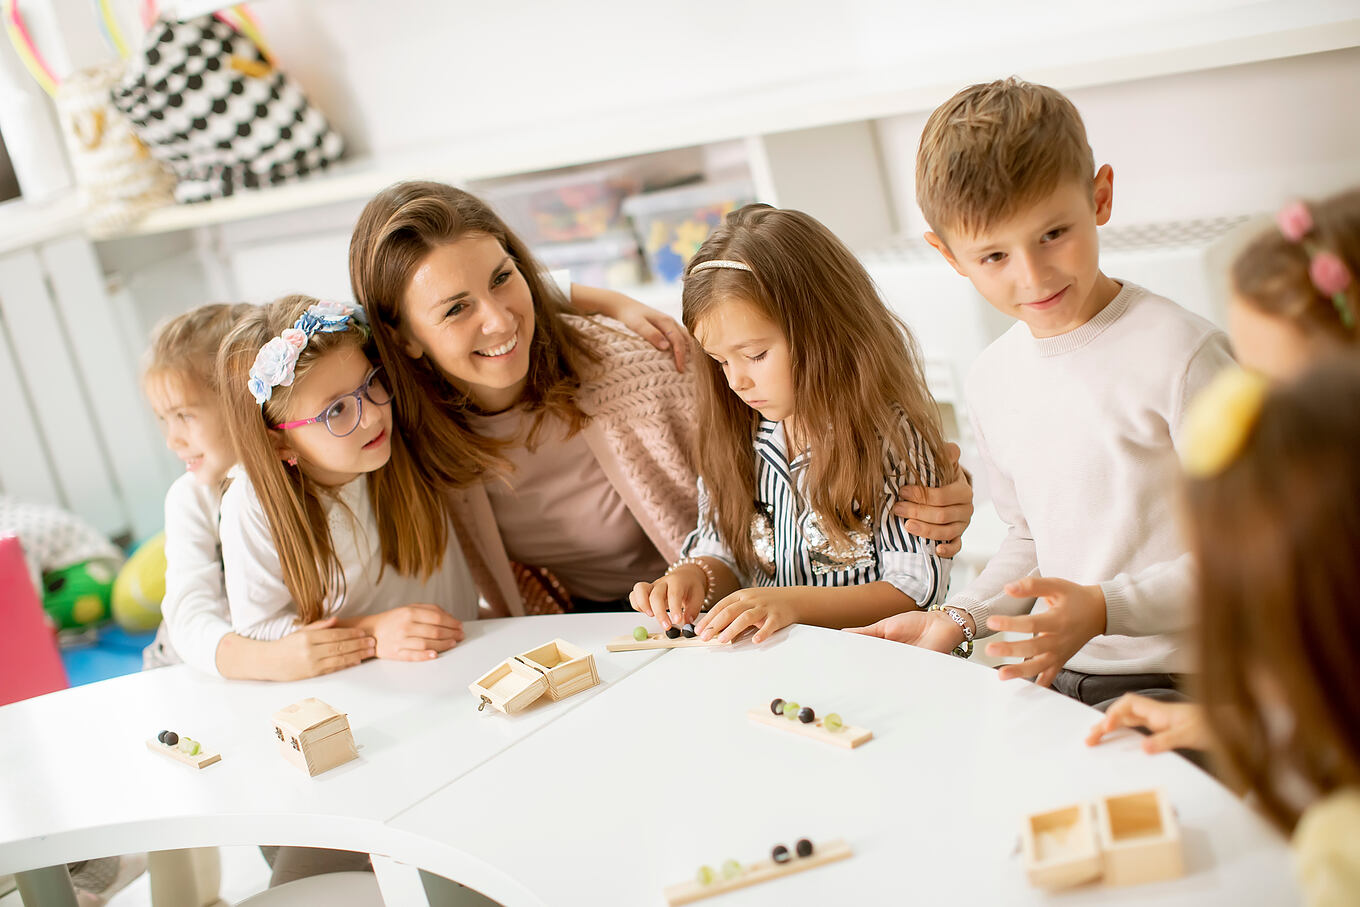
[{"left": 926, "top": 165, "right": 1119, "bottom": 337}]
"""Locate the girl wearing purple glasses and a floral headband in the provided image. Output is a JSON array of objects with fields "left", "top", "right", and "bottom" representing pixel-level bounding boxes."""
[{"left": 218, "top": 296, "right": 477, "bottom": 661}]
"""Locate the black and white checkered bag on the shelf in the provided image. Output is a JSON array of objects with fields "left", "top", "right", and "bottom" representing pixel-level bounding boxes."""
[{"left": 112, "top": 16, "right": 344, "bottom": 201}]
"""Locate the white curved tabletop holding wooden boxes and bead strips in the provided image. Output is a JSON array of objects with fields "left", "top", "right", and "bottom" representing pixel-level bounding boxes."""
[{"left": 0, "top": 615, "right": 1297, "bottom": 907}]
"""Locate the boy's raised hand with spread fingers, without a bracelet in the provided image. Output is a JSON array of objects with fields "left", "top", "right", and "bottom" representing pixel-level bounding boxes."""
[{"left": 987, "top": 577, "right": 1106, "bottom": 687}]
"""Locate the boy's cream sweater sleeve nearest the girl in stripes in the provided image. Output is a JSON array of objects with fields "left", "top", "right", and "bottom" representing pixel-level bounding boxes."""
[{"left": 948, "top": 407, "right": 1039, "bottom": 636}]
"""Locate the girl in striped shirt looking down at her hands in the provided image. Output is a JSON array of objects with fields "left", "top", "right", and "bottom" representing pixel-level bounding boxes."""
[{"left": 630, "top": 205, "right": 953, "bottom": 642}]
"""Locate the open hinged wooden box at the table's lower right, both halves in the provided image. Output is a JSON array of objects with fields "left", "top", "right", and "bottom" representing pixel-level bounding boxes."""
[{"left": 1020, "top": 790, "right": 1185, "bottom": 889}]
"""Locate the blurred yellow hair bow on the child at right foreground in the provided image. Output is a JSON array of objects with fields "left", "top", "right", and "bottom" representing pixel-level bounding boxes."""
[{"left": 1180, "top": 366, "right": 1270, "bottom": 479}]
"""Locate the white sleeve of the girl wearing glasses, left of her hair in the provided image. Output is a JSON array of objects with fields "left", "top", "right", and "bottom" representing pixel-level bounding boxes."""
[{"left": 222, "top": 475, "right": 306, "bottom": 639}]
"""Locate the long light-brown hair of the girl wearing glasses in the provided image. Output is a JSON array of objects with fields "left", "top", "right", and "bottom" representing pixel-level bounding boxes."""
[{"left": 218, "top": 295, "right": 449, "bottom": 623}]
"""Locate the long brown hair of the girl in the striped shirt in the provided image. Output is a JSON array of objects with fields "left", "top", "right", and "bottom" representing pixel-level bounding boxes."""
[{"left": 683, "top": 204, "right": 953, "bottom": 572}]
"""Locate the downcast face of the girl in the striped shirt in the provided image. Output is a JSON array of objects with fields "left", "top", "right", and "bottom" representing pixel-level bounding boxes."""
[{"left": 694, "top": 299, "right": 794, "bottom": 422}]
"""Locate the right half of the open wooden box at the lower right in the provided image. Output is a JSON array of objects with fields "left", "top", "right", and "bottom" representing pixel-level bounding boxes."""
[{"left": 1096, "top": 790, "right": 1186, "bottom": 885}]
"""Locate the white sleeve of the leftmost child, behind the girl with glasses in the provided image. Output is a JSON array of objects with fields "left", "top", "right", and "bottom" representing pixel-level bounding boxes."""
[{"left": 160, "top": 473, "right": 231, "bottom": 677}]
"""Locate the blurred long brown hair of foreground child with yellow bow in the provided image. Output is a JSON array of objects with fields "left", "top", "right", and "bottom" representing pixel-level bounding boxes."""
[{"left": 1186, "top": 359, "right": 1360, "bottom": 831}]
